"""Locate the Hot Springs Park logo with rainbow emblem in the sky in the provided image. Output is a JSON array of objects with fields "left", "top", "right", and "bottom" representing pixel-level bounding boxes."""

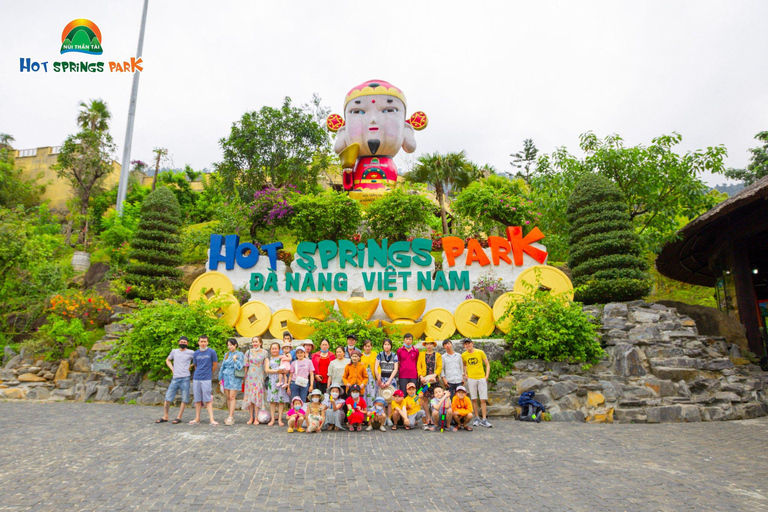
[{"left": 19, "top": 18, "right": 144, "bottom": 74}]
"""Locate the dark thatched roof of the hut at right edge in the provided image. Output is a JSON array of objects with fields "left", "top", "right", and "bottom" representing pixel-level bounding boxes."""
[{"left": 656, "top": 176, "right": 768, "bottom": 286}]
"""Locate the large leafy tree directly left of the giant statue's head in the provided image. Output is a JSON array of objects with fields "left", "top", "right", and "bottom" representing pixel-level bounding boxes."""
[{"left": 216, "top": 97, "right": 330, "bottom": 201}]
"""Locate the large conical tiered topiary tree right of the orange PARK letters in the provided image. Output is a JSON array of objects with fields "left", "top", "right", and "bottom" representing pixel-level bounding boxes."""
[{"left": 567, "top": 174, "right": 651, "bottom": 304}]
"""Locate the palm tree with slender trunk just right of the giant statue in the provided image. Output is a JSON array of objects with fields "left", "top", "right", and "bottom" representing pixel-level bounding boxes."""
[{"left": 405, "top": 151, "right": 475, "bottom": 234}]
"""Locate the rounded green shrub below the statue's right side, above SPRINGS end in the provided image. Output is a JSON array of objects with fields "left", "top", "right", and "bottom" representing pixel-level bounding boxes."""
[{"left": 365, "top": 189, "right": 435, "bottom": 243}]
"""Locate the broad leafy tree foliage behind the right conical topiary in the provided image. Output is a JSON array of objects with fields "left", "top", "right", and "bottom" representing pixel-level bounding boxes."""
[{"left": 531, "top": 132, "right": 726, "bottom": 251}]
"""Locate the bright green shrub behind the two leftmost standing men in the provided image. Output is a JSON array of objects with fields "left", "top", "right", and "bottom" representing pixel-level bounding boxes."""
[{"left": 110, "top": 301, "right": 234, "bottom": 379}]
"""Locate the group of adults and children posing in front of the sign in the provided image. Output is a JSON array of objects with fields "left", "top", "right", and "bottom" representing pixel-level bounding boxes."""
[{"left": 157, "top": 332, "right": 491, "bottom": 432}]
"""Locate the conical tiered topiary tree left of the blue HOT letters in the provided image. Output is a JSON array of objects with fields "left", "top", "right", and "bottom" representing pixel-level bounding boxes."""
[{"left": 125, "top": 187, "right": 186, "bottom": 300}]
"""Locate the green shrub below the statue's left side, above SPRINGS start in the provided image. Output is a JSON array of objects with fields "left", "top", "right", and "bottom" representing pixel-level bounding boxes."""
[{"left": 290, "top": 190, "right": 362, "bottom": 242}]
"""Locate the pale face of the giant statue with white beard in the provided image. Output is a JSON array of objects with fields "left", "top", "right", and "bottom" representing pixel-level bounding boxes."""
[{"left": 345, "top": 94, "right": 405, "bottom": 157}]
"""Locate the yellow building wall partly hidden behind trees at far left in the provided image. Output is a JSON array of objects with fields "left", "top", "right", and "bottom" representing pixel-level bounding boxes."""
[{"left": 15, "top": 146, "right": 120, "bottom": 211}]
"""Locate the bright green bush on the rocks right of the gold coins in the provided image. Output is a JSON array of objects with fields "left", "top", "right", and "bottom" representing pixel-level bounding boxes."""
[{"left": 504, "top": 290, "right": 604, "bottom": 363}]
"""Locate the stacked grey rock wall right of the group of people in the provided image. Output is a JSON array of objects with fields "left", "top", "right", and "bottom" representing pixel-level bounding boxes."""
[{"left": 489, "top": 301, "right": 768, "bottom": 423}]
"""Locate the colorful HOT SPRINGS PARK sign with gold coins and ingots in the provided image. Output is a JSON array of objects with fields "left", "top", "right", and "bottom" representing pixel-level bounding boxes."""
[{"left": 190, "top": 226, "right": 547, "bottom": 335}]
